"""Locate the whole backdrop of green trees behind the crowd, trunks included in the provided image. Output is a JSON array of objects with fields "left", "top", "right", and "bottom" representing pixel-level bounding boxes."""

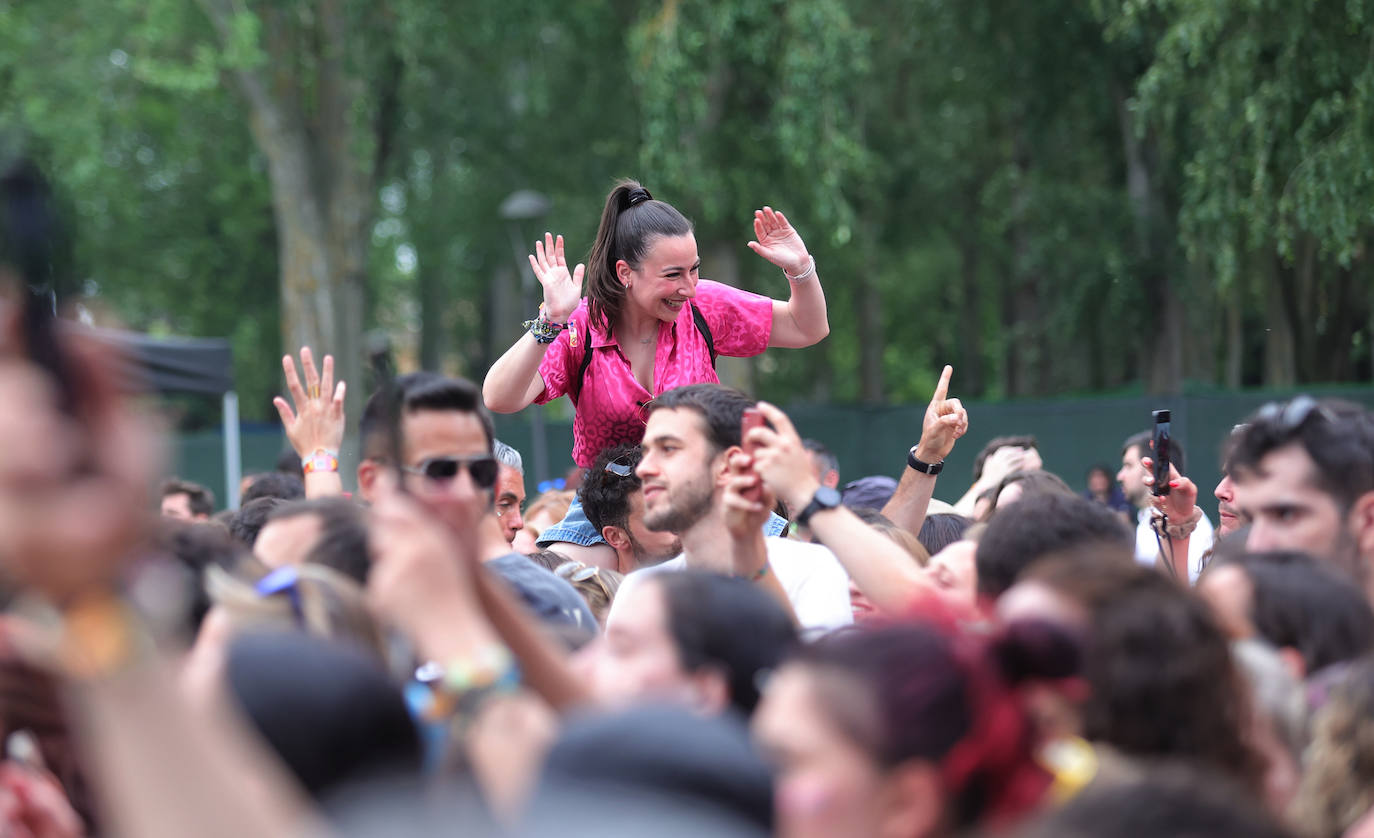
[{"left": 0, "top": 0, "right": 1374, "bottom": 431}]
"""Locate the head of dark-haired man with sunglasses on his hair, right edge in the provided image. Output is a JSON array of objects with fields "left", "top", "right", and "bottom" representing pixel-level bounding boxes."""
[{"left": 1230, "top": 396, "right": 1374, "bottom": 602}]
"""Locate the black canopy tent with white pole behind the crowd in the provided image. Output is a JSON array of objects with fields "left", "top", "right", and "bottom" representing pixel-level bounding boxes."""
[{"left": 96, "top": 328, "right": 243, "bottom": 508}]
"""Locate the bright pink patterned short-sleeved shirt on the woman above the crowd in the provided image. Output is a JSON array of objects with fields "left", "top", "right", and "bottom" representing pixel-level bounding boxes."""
[{"left": 534, "top": 279, "right": 772, "bottom": 468}]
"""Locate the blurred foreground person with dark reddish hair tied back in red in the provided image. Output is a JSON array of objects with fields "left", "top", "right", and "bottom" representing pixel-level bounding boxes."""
[{"left": 753, "top": 624, "right": 1077, "bottom": 838}]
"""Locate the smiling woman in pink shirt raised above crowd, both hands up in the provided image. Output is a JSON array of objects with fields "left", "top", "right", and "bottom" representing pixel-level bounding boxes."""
[{"left": 482, "top": 180, "right": 830, "bottom": 545}]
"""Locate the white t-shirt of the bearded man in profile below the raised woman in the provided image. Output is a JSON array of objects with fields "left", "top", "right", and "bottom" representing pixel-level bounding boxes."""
[{"left": 606, "top": 537, "right": 853, "bottom": 637}]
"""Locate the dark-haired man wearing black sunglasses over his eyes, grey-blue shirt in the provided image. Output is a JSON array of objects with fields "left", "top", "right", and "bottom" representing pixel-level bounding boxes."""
[{"left": 357, "top": 372, "right": 596, "bottom": 631}]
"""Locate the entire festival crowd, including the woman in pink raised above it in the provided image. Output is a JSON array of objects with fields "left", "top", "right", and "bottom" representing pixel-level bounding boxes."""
[{"left": 0, "top": 181, "right": 1374, "bottom": 838}]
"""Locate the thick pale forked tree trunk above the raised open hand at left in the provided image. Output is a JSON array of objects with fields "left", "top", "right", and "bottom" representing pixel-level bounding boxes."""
[{"left": 199, "top": 0, "right": 400, "bottom": 431}]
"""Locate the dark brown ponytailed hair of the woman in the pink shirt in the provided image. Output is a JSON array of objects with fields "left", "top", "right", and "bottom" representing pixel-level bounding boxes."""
[{"left": 587, "top": 179, "right": 691, "bottom": 331}]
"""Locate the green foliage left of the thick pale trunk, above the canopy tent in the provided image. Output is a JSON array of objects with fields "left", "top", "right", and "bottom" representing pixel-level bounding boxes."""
[{"left": 0, "top": 3, "right": 280, "bottom": 416}]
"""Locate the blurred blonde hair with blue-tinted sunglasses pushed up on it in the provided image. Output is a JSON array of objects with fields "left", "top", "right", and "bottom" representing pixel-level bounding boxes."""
[{"left": 205, "top": 562, "right": 383, "bottom": 659}]
